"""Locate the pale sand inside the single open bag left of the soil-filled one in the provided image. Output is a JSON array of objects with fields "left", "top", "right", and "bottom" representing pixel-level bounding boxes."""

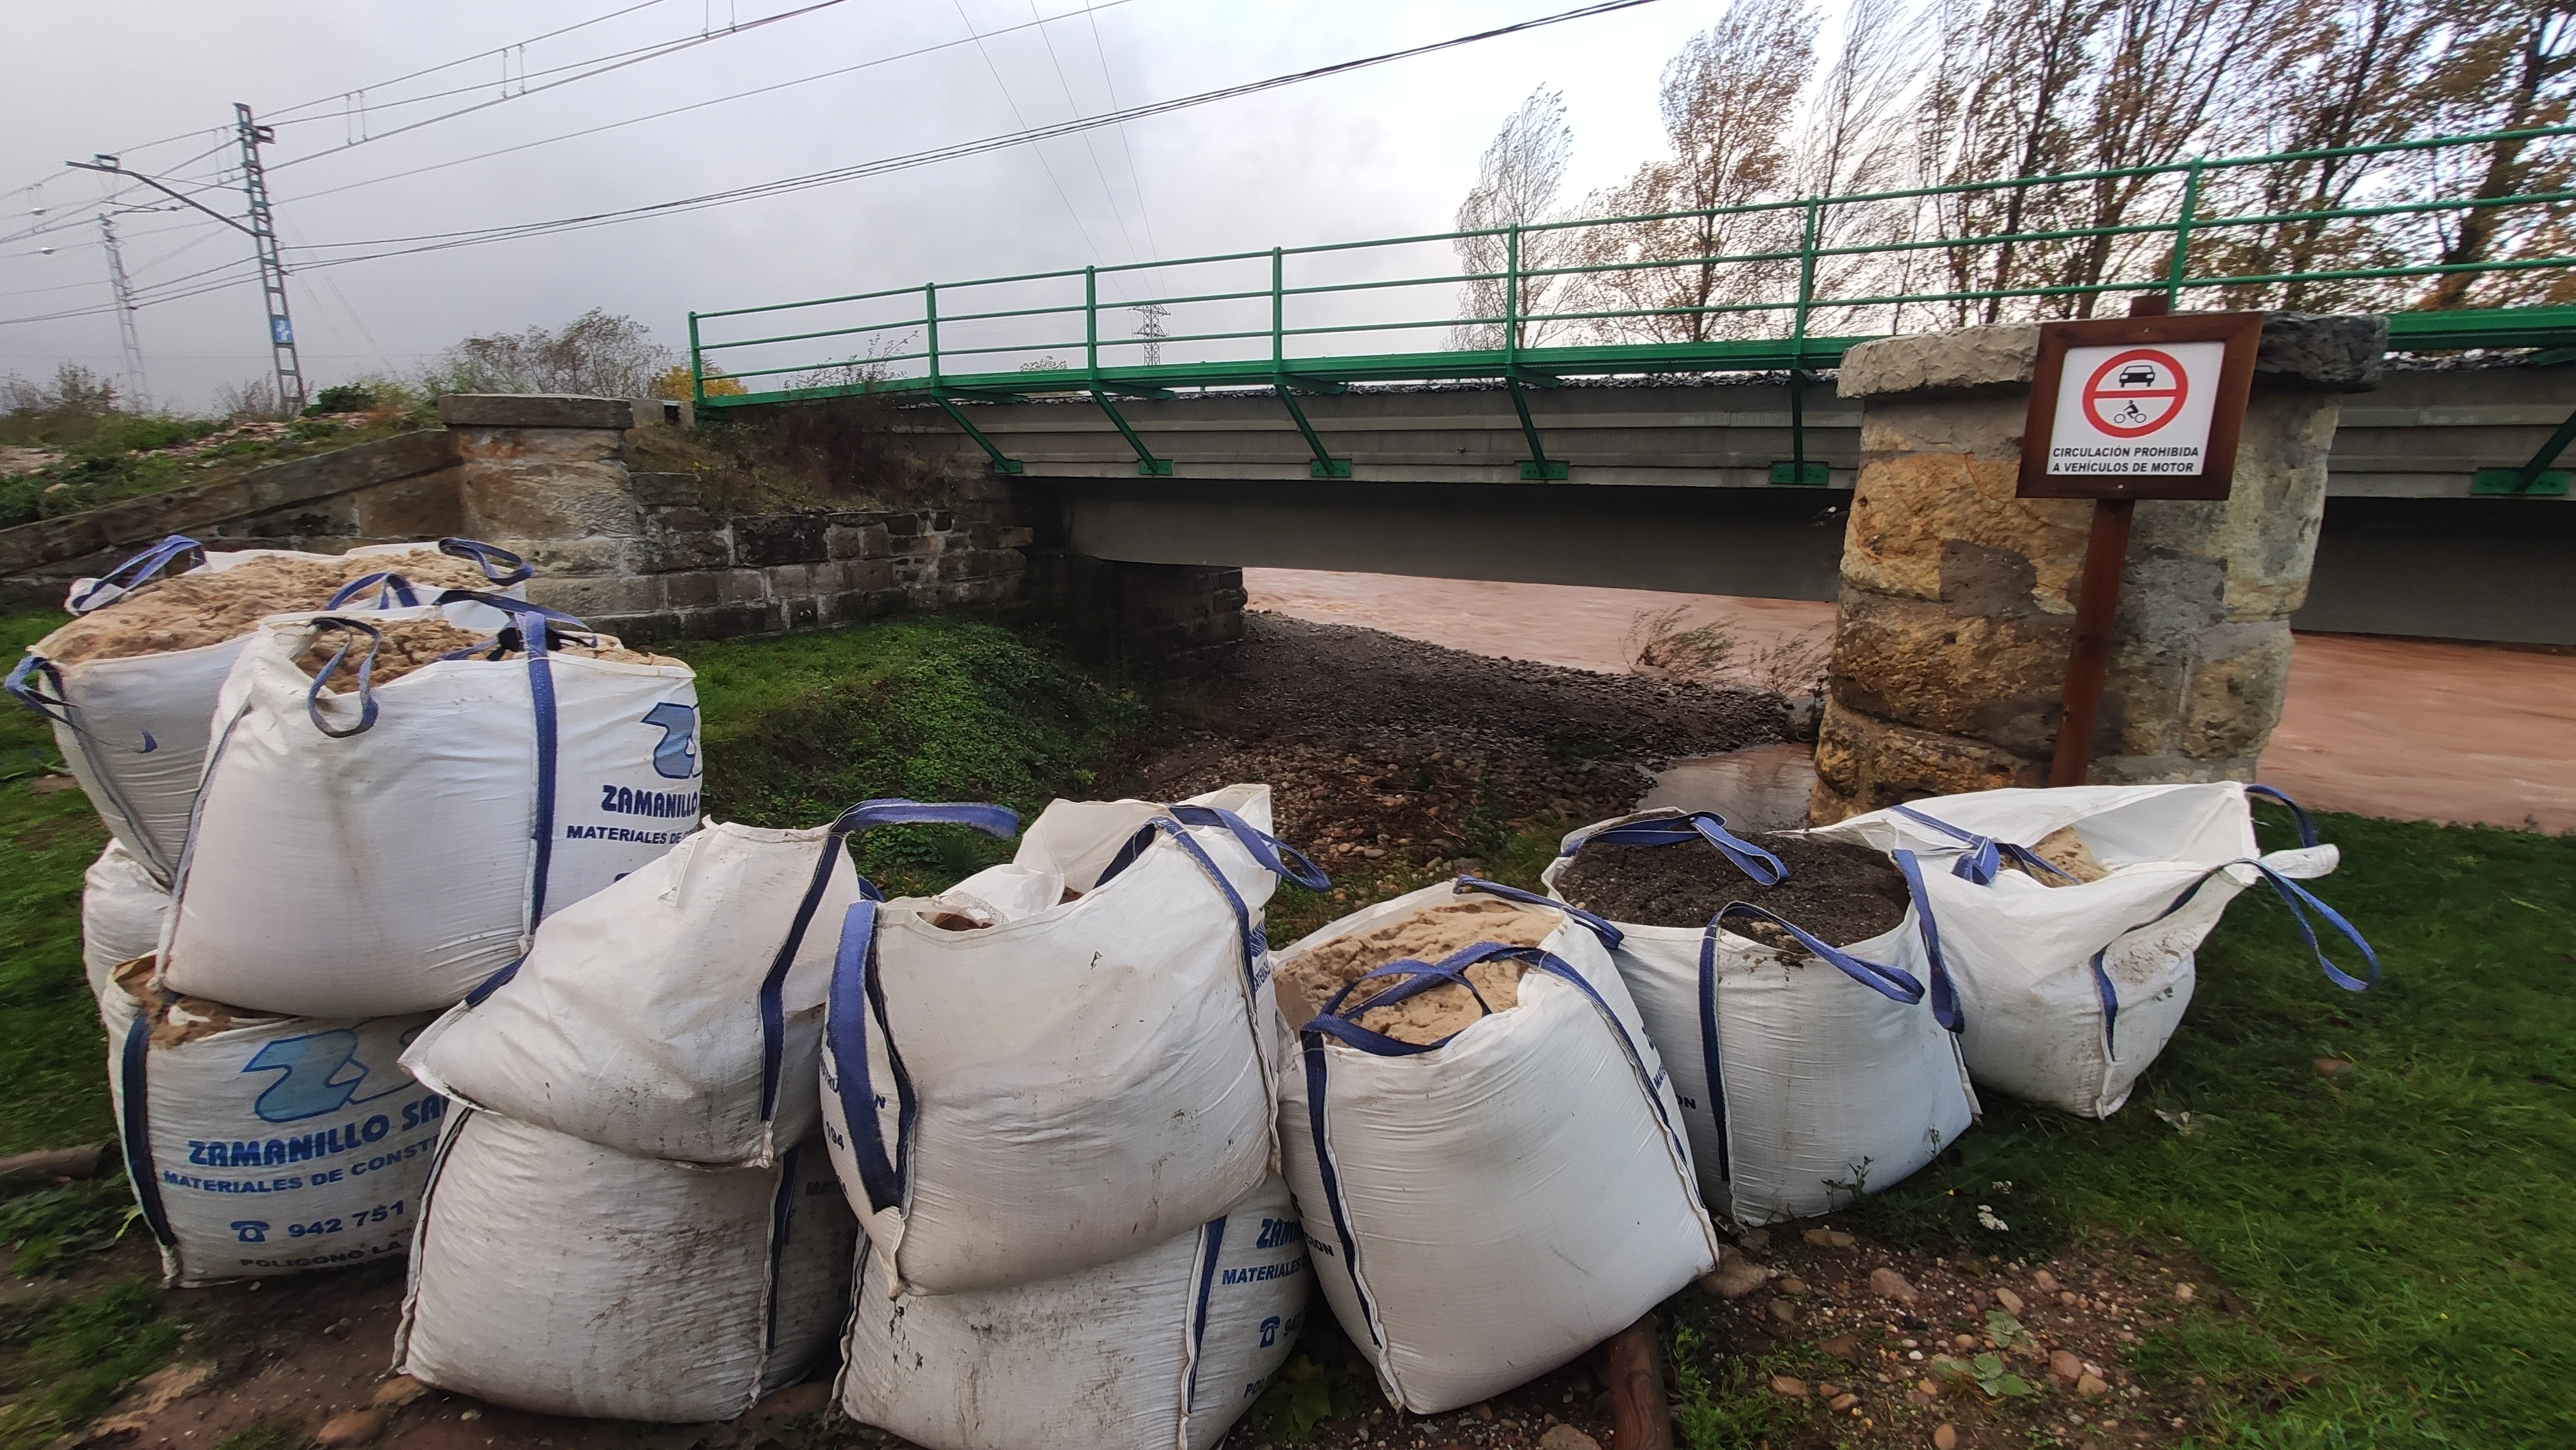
[{"left": 1278, "top": 899, "right": 1561, "bottom": 1046}]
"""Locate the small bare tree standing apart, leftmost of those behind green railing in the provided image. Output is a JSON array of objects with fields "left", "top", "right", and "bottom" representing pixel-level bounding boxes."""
[{"left": 1450, "top": 85, "right": 1574, "bottom": 348}]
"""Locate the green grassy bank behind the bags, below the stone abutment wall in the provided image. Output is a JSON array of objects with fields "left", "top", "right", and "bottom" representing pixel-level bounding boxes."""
[{"left": 670, "top": 615, "right": 1141, "bottom": 893}]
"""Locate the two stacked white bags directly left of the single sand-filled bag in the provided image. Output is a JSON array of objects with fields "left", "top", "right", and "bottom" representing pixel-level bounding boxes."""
[{"left": 822, "top": 786, "right": 1327, "bottom": 1450}]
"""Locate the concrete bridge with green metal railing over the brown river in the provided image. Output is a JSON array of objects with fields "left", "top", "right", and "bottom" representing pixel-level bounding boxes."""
[{"left": 691, "top": 126, "right": 2576, "bottom": 644}]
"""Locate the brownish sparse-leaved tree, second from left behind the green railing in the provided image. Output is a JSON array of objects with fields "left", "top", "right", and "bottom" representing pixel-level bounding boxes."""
[{"left": 1584, "top": 0, "right": 1816, "bottom": 342}]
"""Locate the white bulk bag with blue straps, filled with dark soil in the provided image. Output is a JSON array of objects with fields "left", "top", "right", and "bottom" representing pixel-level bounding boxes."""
[{"left": 1543, "top": 809, "right": 1976, "bottom": 1226}]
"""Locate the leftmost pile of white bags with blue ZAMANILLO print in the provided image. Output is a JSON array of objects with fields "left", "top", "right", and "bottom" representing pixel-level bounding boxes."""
[{"left": 10, "top": 538, "right": 695, "bottom": 1285}]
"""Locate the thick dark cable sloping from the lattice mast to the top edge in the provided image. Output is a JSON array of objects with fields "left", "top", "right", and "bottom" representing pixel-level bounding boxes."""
[{"left": 299, "top": 0, "right": 1657, "bottom": 268}]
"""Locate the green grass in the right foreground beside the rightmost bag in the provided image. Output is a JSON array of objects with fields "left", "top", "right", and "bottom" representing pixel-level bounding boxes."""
[{"left": 1860, "top": 816, "right": 2576, "bottom": 1448}]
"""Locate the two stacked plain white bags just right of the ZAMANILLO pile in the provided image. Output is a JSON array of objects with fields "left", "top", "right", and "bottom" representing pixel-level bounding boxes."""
[{"left": 394, "top": 801, "right": 994, "bottom": 1422}]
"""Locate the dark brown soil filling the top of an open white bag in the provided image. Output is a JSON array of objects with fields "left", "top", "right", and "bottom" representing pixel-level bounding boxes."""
[{"left": 1559, "top": 835, "right": 1906, "bottom": 948}]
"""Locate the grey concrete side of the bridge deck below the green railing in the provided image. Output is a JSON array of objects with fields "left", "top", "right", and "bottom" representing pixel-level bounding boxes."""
[{"left": 871, "top": 366, "right": 2576, "bottom": 644}]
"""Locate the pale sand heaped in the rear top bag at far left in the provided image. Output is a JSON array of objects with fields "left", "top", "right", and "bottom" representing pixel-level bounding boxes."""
[{"left": 36, "top": 549, "right": 512, "bottom": 664}]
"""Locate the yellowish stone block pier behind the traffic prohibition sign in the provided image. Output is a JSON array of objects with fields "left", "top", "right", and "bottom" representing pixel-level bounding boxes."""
[{"left": 1811, "top": 317, "right": 2383, "bottom": 824}]
